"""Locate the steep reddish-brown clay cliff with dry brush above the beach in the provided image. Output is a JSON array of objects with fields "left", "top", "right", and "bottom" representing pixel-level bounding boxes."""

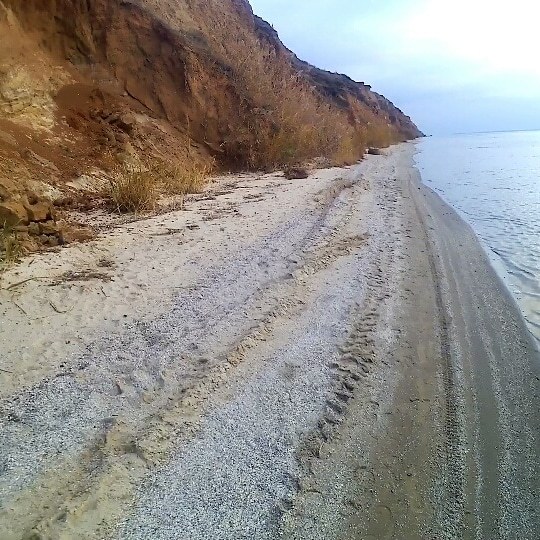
[{"left": 0, "top": 0, "right": 420, "bottom": 253}]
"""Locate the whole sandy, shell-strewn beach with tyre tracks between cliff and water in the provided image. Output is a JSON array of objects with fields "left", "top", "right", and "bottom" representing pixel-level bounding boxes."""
[{"left": 0, "top": 143, "right": 540, "bottom": 540}]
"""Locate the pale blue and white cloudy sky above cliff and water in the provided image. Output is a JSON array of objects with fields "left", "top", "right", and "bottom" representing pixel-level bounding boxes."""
[{"left": 251, "top": 0, "right": 540, "bottom": 134}]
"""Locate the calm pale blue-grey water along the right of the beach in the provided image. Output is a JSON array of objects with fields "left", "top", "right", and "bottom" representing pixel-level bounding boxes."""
[{"left": 415, "top": 131, "right": 540, "bottom": 341}]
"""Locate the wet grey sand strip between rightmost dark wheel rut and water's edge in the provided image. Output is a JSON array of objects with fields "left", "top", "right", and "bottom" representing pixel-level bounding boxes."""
[{"left": 413, "top": 156, "right": 540, "bottom": 538}]
